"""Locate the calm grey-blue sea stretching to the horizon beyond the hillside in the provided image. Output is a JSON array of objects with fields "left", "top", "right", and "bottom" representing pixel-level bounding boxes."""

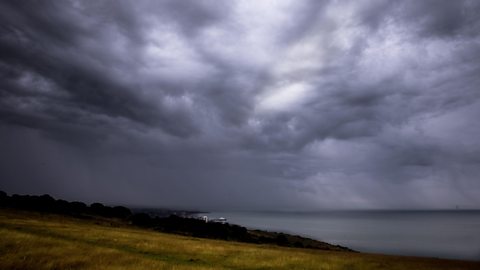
[{"left": 203, "top": 211, "right": 480, "bottom": 260}]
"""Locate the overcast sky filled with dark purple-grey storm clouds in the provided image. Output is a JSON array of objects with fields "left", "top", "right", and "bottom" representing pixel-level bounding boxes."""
[{"left": 0, "top": 0, "right": 480, "bottom": 210}]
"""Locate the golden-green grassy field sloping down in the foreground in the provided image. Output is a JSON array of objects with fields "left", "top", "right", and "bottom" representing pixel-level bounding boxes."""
[{"left": 0, "top": 209, "right": 480, "bottom": 270}]
